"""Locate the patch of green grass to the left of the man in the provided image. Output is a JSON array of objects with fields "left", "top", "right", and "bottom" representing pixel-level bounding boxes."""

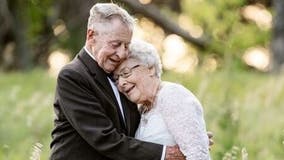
[{"left": 0, "top": 70, "right": 55, "bottom": 160}]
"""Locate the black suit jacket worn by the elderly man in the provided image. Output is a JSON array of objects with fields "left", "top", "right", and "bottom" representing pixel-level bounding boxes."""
[{"left": 50, "top": 49, "right": 162, "bottom": 160}]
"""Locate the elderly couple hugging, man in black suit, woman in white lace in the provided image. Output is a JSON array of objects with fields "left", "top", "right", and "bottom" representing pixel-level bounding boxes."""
[{"left": 50, "top": 3, "right": 210, "bottom": 160}]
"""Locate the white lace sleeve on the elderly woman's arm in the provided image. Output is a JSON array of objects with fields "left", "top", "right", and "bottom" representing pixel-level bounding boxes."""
[{"left": 161, "top": 85, "right": 210, "bottom": 160}]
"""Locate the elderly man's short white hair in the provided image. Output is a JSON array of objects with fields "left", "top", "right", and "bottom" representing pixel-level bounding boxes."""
[{"left": 88, "top": 3, "right": 135, "bottom": 30}]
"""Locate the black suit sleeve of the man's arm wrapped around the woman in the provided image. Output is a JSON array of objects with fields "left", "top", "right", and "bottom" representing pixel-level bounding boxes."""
[{"left": 57, "top": 69, "right": 163, "bottom": 160}]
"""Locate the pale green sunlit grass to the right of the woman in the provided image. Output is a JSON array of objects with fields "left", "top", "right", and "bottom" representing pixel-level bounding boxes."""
[{"left": 164, "top": 70, "right": 284, "bottom": 160}]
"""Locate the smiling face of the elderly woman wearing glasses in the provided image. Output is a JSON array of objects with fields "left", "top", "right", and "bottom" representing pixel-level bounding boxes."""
[{"left": 114, "top": 58, "right": 154, "bottom": 104}]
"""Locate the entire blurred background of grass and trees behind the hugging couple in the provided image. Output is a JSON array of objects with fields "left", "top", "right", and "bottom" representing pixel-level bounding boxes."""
[{"left": 0, "top": 0, "right": 284, "bottom": 160}]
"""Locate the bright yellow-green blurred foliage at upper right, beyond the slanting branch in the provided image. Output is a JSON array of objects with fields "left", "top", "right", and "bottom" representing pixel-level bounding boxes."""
[{"left": 182, "top": 0, "right": 271, "bottom": 67}]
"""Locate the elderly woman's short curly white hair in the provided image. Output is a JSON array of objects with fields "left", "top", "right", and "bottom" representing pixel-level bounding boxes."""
[{"left": 128, "top": 39, "right": 162, "bottom": 78}]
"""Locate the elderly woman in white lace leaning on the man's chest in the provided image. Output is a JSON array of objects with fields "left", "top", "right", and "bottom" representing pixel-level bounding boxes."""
[{"left": 114, "top": 40, "right": 210, "bottom": 160}]
